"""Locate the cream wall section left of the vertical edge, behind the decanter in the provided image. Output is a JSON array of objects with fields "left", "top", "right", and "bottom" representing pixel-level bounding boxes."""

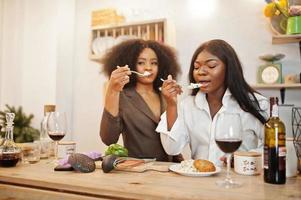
[{"left": 0, "top": 0, "right": 75, "bottom": 138}]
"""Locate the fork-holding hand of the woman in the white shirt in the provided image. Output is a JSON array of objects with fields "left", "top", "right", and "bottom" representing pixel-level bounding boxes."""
[{"left": 161, "top": 75, "right": 183, "bottom": 105}]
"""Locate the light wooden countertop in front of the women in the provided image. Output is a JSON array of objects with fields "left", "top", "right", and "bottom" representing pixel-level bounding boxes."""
[{"left": 0, "top": 160, "right": 301, "bottom": 200}]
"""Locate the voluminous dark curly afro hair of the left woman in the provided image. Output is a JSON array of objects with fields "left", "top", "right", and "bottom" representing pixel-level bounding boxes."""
[{"left": 101, "top": 39, "right": 181, "bottom": 92}]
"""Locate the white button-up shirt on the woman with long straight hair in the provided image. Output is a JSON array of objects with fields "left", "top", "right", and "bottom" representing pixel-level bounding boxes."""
[{"left": 156, "top": 90, "right": 269, "bottom": 165}]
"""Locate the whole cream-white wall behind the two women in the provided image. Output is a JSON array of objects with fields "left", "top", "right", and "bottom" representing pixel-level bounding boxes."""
[{"left": 0, "top": 0, "right": 301, "bottom": 155}]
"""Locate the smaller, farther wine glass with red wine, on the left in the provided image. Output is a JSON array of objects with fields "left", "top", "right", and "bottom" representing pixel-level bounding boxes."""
[{"left": 47, "top": 111, "right": 67, "bottom": 161}]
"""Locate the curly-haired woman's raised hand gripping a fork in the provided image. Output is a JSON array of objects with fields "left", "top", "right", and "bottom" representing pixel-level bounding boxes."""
[{"left": 108, "top": 65, "right": 131, "bottom": 92}]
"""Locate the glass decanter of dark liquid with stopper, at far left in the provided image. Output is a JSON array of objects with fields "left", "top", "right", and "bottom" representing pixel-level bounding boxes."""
[{"left": 0, "top": 113, "right": 21, "bottom": 167}]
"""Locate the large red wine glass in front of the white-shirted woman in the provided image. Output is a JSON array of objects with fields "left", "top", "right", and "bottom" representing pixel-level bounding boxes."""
[{"left": 215, "top": 112, "right": 242, "bottom": 188}]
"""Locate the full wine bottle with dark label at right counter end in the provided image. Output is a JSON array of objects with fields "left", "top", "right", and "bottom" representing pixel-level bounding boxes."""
[{"left": 264, "top": 97, "right": 286, "bottom": 184}]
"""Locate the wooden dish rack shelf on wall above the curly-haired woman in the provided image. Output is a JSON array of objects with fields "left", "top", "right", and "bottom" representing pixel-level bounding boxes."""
[{"left": 89, "top": 19, "right": 166, "bottom": 62}]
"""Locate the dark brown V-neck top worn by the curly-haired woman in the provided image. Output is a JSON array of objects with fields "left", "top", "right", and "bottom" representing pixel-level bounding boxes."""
[{"left": 100, "top": 88, "right": 172, "bottom": 161}]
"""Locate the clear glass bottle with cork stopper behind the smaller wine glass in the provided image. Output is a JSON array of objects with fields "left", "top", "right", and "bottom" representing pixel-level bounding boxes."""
[{"left": 40, "top": 105, "right": 55, "bottom": 159}]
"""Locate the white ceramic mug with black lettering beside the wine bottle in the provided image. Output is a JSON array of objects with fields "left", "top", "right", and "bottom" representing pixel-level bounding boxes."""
[{"left": 234, "top": 151, "right": 262, "bottom": 175}]
